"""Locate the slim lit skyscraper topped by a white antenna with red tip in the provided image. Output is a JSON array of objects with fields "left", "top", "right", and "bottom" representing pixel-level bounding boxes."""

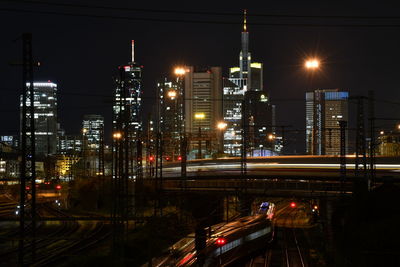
[{"left": 113, "top": 40, "right": 143, "bottom": 140}]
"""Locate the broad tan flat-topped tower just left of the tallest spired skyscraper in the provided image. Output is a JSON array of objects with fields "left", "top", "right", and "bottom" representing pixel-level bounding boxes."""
[{"left": 184, "top": 67, "right": 223, "bottom": 158}]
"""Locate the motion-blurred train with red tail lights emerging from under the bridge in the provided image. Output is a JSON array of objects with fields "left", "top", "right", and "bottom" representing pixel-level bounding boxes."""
[{"left": 152, "top": 203, "right": 274, "bottom": 267}]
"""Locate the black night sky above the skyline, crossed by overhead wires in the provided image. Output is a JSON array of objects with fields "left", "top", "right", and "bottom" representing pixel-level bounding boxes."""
[{"left": 0, "top": 0, "right": 400, "bottom": 152}]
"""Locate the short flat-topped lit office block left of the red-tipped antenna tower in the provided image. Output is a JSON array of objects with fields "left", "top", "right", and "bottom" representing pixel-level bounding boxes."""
[{"left": 82, "top": 114, "right": 104, "bottom": 151}]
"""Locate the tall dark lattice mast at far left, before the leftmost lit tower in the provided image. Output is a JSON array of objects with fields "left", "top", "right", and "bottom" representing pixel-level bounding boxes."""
[{"left": 18, "top": 33, "right": 36, "bottom": 266}]
